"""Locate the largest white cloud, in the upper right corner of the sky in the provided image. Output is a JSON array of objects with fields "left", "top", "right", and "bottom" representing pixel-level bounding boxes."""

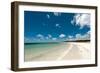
[{"left": 71, "top": 13, "right": 90, "bottom": 29}]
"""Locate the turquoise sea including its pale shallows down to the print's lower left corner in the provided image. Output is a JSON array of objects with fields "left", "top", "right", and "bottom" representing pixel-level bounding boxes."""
[{"left": 24, "top": 42, "right": 66, "bottom": 61}]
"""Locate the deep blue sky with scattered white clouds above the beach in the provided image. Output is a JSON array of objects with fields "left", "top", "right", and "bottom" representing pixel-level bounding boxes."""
[{"left": 24, "top": 11, "right": 90, "bottom": 43}]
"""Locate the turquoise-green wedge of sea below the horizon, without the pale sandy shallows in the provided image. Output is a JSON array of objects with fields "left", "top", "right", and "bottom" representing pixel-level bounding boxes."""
[{"left": 24, "top": 43, "right": 60, "bottom": 55}]
